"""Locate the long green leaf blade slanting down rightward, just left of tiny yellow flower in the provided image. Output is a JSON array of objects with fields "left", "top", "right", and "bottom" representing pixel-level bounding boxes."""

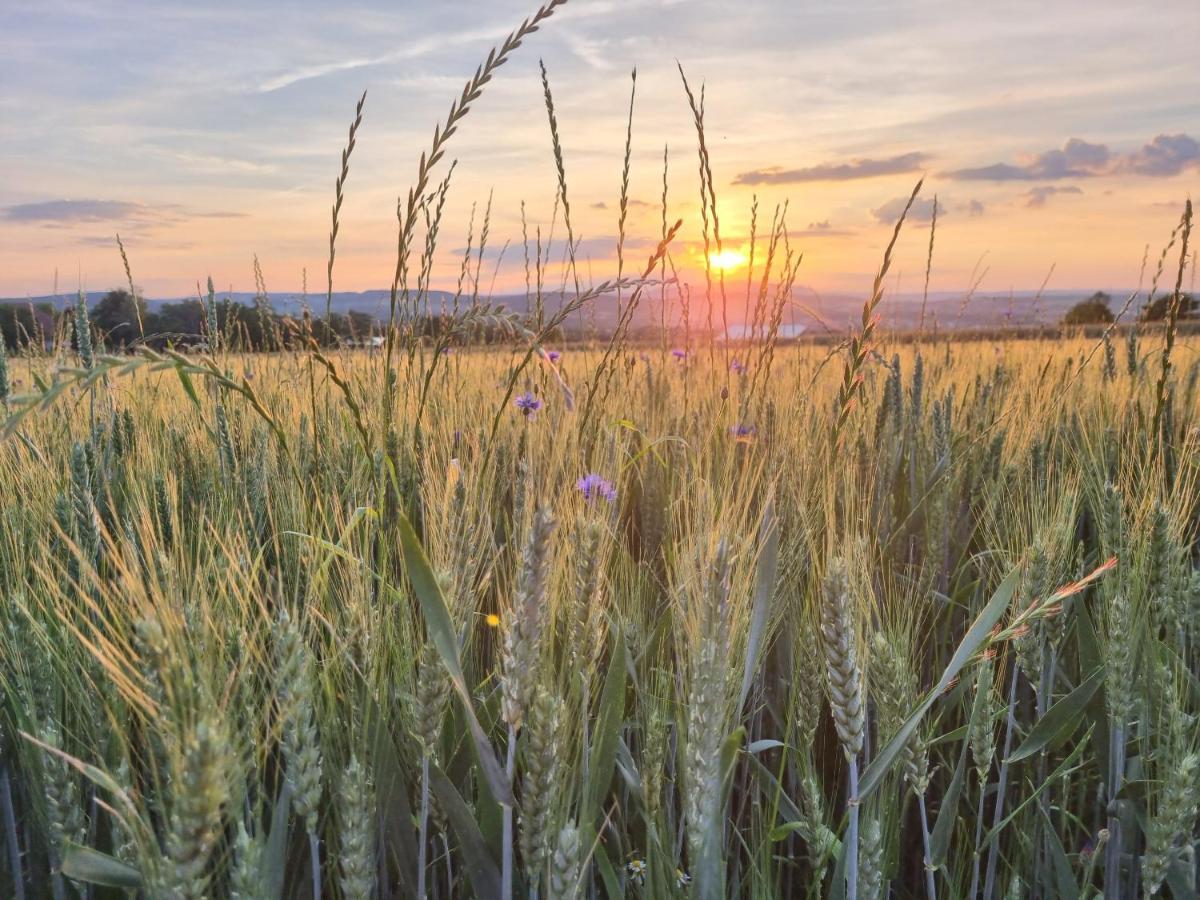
[{"left": 397, "top": 510, "right": 511, "bottom": 806}]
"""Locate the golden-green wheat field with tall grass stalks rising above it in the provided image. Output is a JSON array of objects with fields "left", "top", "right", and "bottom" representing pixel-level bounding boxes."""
[{"left": 0, "top": 0, "right": 1200, "bottom": 900}]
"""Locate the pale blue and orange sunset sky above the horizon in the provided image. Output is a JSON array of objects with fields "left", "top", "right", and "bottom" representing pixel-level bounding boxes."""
[{"left": 0, "top": 0, "right": 1200, "bottom": 307}]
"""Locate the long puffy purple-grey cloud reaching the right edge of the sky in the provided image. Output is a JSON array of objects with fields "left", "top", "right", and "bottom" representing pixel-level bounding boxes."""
[{"left": 946, "top": 134, "right": 1200, "bottom": 181}]
